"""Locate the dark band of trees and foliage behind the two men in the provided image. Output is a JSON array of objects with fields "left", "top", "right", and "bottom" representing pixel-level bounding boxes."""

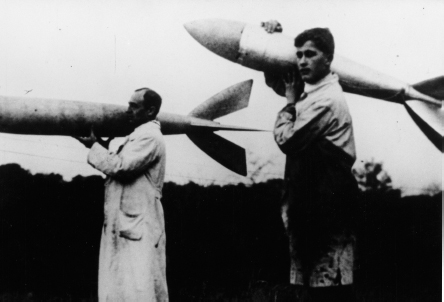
[{"left": 0, "top": 162, "right": 442, "bottom": 301}]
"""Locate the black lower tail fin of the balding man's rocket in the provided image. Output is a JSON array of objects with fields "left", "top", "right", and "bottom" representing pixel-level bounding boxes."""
[{"left": 187, "top": 131, "right": 247, "bottom": 176}]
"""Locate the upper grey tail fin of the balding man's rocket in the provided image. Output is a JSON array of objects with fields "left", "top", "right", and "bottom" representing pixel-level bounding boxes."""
[{"left": 188, "top": 80, "right": 253, "bottom": 121}]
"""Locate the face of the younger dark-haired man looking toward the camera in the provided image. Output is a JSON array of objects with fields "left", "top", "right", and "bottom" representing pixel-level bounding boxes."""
[{"left": 296, "top": 41, "right": 331, "bottom": 84}]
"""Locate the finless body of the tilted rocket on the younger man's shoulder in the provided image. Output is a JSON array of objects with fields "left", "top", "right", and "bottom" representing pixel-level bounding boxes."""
[{"left": 185, "top": 19, "right": 441, "bottom": 106}]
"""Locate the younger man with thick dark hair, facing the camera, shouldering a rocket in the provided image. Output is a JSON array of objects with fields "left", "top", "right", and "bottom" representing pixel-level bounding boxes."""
[{"left": 262, "top": 21, "right": 358, "bottom": 301}]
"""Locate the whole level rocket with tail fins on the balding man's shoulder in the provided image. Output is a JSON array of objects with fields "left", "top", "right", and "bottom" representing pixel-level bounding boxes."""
[{"left": 0, "top": 80, "right": 261, "bottom": 176}]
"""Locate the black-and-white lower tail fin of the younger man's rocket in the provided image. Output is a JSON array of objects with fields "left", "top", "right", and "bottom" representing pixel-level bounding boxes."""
[{"left": 404, "top": 100, "right": 444, "bottom": 152}]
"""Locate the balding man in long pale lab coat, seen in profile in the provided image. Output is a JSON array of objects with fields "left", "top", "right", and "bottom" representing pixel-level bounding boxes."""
[{"left": 77, "top": 88, "right": 168, "bottom": 302}]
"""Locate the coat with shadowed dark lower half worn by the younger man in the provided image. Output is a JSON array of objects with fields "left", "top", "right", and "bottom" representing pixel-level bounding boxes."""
[{"left": 273, "top": 73, "right": 358, "bottom": 287}]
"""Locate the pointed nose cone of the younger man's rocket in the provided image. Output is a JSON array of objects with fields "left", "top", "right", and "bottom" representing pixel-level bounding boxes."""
[{"left": 184, "top": 19, "right": 245, "bottom": 62}]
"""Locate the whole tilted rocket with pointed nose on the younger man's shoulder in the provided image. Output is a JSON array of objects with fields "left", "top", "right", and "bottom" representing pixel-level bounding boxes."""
[{"left": 185, "top": 19, "right": 444, "bottom": 152}]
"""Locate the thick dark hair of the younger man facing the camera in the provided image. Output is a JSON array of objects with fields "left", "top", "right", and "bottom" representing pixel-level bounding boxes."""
[{"left": 294, "top": 27, "right": 335, "bottom": 57}]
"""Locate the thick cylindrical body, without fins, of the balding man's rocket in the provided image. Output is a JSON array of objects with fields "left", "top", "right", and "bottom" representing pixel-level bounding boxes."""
[{"left": 0, "top": 96, "right": 192, "bottom": 137}]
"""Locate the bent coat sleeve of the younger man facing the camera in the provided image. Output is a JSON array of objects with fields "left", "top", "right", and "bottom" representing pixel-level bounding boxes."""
[{"left": 273, "top": 101, "right": 332, "bottom": 155}]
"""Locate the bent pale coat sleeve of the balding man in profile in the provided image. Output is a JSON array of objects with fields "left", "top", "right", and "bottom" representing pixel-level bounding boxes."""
[{"left": 88, "top": 135, "right": 158, "bottom": 179}]
